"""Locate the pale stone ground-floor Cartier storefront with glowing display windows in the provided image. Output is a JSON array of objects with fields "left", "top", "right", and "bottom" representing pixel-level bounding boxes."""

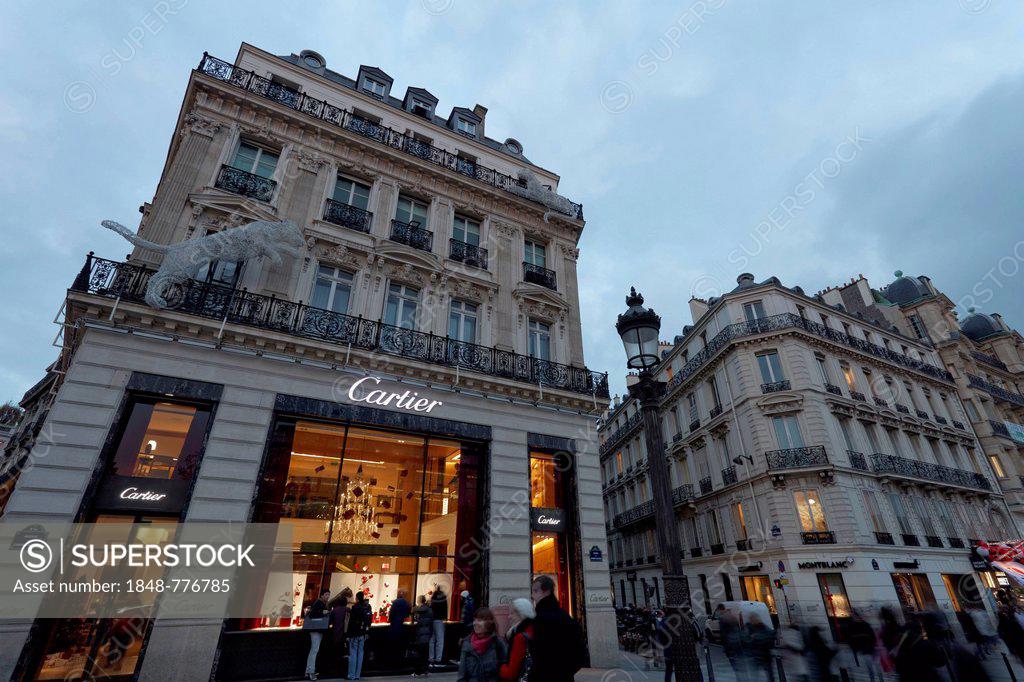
[{"left": 2, "top": 326, "right": 616, "bottom": 680}]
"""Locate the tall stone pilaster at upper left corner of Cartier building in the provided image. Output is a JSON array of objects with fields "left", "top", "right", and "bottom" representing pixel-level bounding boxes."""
[{"left": 138, "top": 113, "right": 223, "bottom": 264}]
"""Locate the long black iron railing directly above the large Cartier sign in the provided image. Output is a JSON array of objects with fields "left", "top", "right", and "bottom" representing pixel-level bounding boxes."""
[{"left": 72, "top": 253, "right": 608, "bottom": 397}]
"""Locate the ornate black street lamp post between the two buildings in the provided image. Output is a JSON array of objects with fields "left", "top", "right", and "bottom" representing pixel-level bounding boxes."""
[{"left": 615, "top": 288, "right": 702, "bottom": 682}]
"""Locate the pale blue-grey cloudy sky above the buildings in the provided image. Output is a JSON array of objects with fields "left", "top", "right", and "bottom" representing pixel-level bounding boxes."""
[{"left": 0, "top": 0, "right": 1024, "bottom": 401}]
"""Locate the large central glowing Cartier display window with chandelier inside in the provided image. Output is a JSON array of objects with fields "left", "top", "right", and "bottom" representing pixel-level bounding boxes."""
[{"left": 241, "top": 419, "right": 480, "bottom": 631}]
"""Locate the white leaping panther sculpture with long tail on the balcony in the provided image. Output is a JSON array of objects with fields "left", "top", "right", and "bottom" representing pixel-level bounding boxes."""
[{"left": 100, "top": 220, "right": 304, "bottom": 308}]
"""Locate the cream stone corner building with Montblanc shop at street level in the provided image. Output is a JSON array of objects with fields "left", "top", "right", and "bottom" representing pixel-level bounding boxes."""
[{"left": 600, "top": 273, "right": 1019, "bottom": 636}]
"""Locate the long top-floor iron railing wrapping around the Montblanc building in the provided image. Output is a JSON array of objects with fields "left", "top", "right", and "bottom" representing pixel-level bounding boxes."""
[{"left": 665, "top": 312, "right": 953, "bottom": 400}]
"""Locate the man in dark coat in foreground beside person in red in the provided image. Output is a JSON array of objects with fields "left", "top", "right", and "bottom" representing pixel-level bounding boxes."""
[{"left": 529, "top": 576, "right": 587, "bottom": 682}]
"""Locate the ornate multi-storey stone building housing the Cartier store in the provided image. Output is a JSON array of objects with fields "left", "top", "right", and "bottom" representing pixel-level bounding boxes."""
[{"left": 0, "top": 44, "right": 616, "bottom": 680}]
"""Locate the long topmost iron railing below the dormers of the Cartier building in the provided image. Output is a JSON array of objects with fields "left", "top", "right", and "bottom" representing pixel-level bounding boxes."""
[{"left": 198, "top": 53, "right": 583, "bottom": 220}]
